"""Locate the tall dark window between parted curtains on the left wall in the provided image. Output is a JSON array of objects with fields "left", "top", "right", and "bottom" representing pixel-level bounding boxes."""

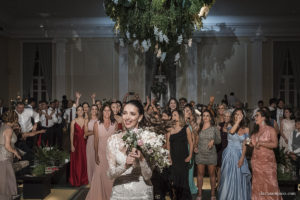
[{"left": 30, "top": 51, "right": 48, "bottom": 101}]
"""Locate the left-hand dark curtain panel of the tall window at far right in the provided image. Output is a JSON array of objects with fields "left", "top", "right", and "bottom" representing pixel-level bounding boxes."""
[{"left": 273, "top": 42, "right": 288, "bottom": 97}]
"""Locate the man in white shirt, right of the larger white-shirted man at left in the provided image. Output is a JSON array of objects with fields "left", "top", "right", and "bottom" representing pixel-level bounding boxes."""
[{"left": 40, "top": 101, "right": 57, "bottom": 146}]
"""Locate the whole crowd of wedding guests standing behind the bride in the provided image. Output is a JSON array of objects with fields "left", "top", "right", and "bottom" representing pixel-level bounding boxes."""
[{"left": 0, "top": 92, "right": 300, "bottom": 200}]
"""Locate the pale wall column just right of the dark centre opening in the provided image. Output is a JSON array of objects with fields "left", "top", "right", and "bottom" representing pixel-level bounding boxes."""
[{"left": 187, "top": 39, "right": 198, "bottom": 102}]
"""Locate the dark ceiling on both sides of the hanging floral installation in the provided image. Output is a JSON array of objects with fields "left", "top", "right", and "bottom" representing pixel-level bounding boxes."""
[{"left": 0, "top": 0, "right": 300, "bottom": 37}]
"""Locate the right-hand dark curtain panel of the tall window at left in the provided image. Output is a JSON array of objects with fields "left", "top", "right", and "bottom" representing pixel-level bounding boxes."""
[{"left": 38, "top": 43, "right": 52, "bottom": 99}]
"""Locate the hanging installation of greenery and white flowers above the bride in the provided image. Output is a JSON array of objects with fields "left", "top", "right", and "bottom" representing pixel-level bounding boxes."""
[{"left": 104, "top": 0, "right": 214, "bottom": 64}]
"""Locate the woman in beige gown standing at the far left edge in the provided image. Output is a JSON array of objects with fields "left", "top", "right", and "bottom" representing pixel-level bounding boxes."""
[{"left": 0, "top": 111, "right": 21, "bottom": 200}]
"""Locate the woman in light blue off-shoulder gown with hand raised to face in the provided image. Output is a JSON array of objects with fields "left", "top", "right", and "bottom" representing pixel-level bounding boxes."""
[{"left": 218, "top": 108, "right": 251, "bottom": 200}]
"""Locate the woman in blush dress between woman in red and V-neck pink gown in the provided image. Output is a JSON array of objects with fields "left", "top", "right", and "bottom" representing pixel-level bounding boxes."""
[{"left": 84, "top": 104, "right": 99, "bottom": 183}]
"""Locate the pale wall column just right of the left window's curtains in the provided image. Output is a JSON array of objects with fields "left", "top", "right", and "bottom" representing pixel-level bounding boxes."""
[{"left": 52, "top": 39, "right": 67, "bottom": 99}]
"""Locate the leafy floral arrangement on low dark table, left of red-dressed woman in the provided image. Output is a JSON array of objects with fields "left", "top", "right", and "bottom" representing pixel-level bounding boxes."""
[{"left": 32, "top": 147, "right": 70, "bottom": 176}]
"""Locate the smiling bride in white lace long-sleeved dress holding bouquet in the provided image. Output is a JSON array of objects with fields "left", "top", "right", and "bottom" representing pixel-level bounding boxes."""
[{"left": 106, "top": 100, "right": 153, "bottom": 200}]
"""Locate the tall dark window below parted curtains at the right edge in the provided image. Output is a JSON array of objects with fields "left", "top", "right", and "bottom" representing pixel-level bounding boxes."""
[{"left": 279, "top": 51, "right": 298, "bottom": 106}]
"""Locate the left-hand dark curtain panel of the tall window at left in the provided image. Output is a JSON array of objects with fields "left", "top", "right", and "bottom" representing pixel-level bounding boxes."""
[{"left": 23, "top": 43, "right": 37, "bottom": 97}]
